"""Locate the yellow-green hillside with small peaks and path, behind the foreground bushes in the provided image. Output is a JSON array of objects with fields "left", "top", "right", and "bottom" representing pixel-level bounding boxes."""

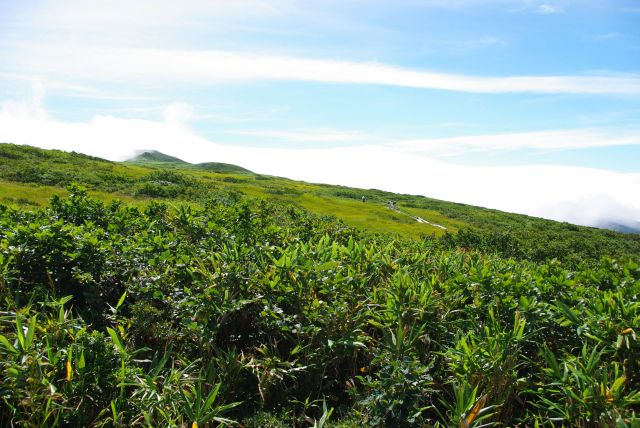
[{"left": 0, "top": 144, "right": 640, "bottom": 263}]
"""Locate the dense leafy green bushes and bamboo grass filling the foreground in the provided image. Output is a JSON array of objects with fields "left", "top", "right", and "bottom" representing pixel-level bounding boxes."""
[{"left": 0, "top": 187, "right": 640, "bottom": 427}]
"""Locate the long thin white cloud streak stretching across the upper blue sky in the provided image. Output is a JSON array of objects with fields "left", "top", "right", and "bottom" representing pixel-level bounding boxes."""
[{"left": 9, "top": 45, "right": 640, "bottom": 96}]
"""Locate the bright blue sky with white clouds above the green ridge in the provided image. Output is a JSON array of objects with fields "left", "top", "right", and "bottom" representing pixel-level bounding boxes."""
[{"left": 0, "top": 0, "right": 640, "bottom": 226}]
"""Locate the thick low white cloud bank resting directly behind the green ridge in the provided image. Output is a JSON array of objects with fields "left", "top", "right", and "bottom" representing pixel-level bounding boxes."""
[{"left": 0, "top": 106, "right": 640, "bottom": 229}]
